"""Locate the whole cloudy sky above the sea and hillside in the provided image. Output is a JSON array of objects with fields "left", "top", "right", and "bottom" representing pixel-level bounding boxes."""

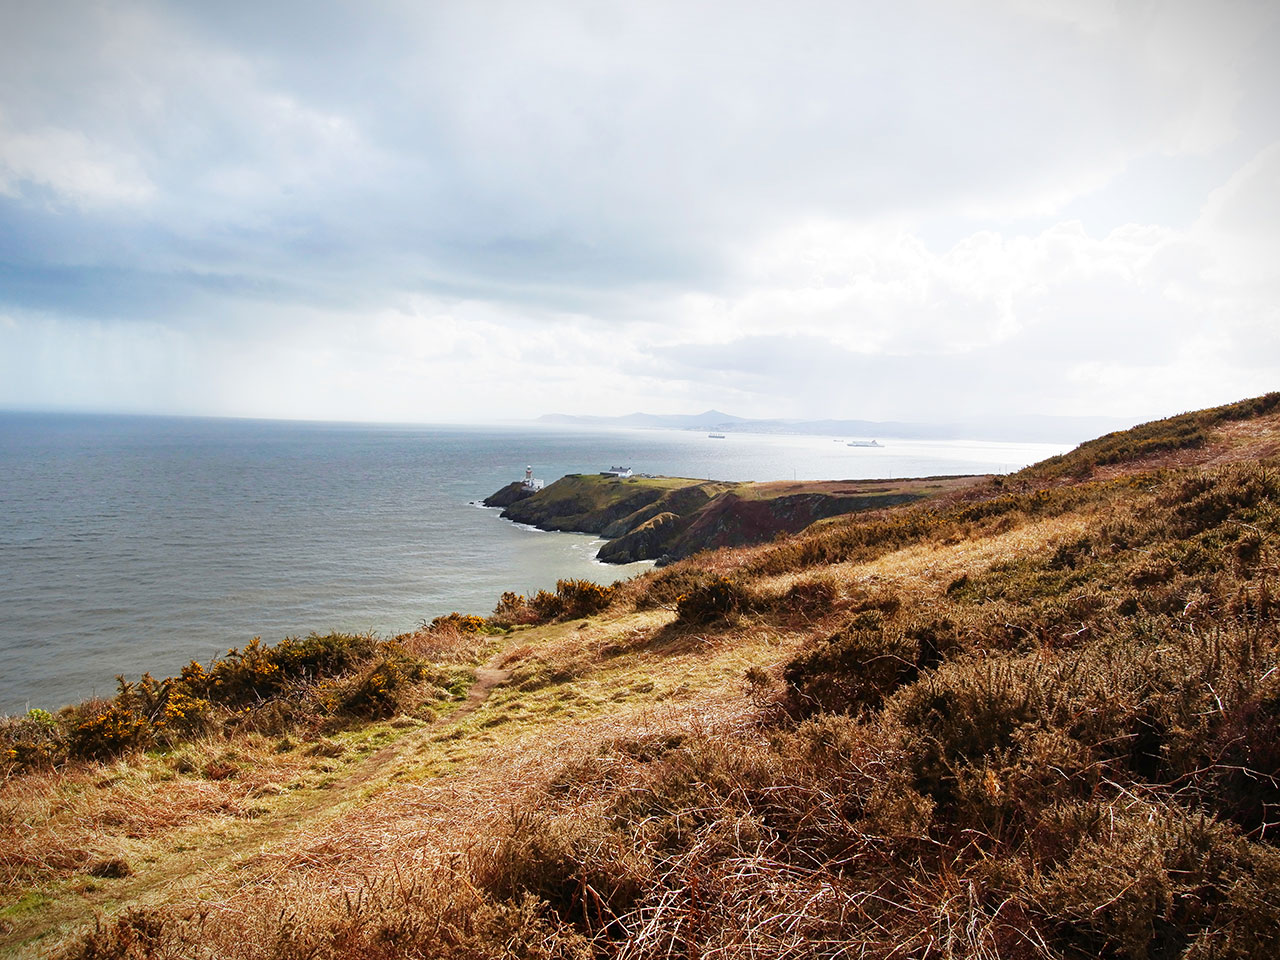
[{"left": 0, "top": 0, "right": 1280, "bottom": 422}]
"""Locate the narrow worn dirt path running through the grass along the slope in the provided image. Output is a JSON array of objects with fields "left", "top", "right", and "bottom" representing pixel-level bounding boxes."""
[{"left": 0, "top": 663, "right": 511, "bottom": 956}]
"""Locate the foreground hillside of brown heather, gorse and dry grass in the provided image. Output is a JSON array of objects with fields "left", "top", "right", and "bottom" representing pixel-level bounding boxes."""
[{"left": 0, "top": 398, "right": 1280, "bottom": 960}]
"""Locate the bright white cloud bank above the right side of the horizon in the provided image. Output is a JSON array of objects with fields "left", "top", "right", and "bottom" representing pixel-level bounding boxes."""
[{"left": 634, "top": 140, "right": 1280, "bottom": 417}]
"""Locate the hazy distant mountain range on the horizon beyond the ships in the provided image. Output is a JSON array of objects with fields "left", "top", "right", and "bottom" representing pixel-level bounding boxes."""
[{"left": 538, "top": 410, "right": 1137, "bottom": 443}]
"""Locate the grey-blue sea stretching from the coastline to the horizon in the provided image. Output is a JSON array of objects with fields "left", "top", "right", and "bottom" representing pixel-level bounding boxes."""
[{"left": 0, "top": 413, "right": 1070, "bottom": 714}]
